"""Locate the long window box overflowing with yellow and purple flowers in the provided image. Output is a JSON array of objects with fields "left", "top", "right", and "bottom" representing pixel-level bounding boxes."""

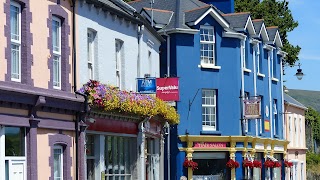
[{"left": 79, "top": 80, "right": 179, "bottom": 124}]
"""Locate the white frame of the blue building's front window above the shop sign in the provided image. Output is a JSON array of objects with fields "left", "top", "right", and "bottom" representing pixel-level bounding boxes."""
[{"left": 201, "top": 89, "right": 217, "bottom": 131}]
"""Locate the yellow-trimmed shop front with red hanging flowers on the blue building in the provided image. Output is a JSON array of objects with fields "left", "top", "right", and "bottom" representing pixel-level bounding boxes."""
[{"left": 179, "top": 135, "right": 287, "bottom": 180}]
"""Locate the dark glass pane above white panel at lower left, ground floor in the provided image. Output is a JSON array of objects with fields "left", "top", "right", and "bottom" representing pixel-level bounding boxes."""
[{"left": 5, "top": 127, "right": 25, "bottom": 156}]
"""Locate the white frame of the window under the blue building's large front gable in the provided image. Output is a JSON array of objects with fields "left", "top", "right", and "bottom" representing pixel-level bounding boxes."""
[{"left": 200, "top": 25, "right": 217, "bottom": 67}]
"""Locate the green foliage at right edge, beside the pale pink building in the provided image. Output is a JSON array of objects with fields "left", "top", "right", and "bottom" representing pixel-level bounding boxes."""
[{"left": 305, "top": 107, "right": 320, "bottom": 141}]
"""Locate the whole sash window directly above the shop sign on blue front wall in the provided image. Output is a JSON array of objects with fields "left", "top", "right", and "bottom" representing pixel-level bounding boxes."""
[{"left": 202, "top": 89, "right": 217, "bottom": 131}]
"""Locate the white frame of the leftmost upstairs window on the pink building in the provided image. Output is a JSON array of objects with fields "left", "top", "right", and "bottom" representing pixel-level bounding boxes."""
[{"left": 10, "top": 1, "right": 21, "bottom": 82}]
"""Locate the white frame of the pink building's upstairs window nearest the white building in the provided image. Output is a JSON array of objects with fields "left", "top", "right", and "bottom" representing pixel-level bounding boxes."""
[{"left": 52, "top": 16, "right": 61, "bottom": 90}]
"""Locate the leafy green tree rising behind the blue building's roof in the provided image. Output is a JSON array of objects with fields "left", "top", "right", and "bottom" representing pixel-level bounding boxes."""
[{"left": 235, "top": 0, "right": 301, "bottom": 65}]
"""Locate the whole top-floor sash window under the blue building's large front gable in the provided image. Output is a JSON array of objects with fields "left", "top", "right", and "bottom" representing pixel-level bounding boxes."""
[{"left": 200, "top": 26, "right": 216, "bottom": 65}]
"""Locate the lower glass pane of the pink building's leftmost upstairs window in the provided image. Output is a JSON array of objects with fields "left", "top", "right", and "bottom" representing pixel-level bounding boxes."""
[{"left": 11, "top": 44, "right": 20, "bottom": 79}]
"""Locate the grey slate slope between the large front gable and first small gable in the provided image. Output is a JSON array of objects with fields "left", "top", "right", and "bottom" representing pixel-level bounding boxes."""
[{"left": 222, "top": 12, "right": 250, "bottom": 28}]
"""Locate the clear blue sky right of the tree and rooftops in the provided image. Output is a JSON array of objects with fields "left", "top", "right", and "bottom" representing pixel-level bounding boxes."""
[{"left": 284, "top": 0, "right": 320, "bottom": 91}]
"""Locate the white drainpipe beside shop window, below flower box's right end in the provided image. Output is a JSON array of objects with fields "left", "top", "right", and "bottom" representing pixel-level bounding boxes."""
[{"left": 138, "top": 116, "right": 151, "bottom": 180}]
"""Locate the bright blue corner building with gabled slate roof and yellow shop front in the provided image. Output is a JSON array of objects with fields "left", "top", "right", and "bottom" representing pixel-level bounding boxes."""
[{"left": 130, "top": 0, "right": 288, "bottom": 180}]
